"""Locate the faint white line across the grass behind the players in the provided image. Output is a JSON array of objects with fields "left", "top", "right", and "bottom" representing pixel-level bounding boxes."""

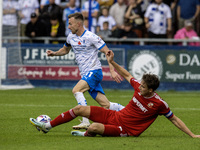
[{"left": 0, "top": 104, "right": 200, "bottom": 111}]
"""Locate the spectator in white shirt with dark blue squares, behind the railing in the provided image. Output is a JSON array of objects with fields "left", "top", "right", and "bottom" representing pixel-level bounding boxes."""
[{"left": 144, "top": 0, "right": 172, "bottom": 44}]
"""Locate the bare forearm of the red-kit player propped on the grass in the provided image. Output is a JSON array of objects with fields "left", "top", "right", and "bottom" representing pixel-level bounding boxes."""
[{"left": 169, "top": 115, "right": 200, "bottom": 138}]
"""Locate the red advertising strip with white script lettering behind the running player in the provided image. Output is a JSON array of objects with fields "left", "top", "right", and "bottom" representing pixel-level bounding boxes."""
[{"left": 8, "top": 65, "right": 113, "bottom": 81}]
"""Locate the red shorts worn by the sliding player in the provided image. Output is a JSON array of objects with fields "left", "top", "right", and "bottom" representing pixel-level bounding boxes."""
[{"left": 89, "top": 106, "right": 128, "bottom": 136}]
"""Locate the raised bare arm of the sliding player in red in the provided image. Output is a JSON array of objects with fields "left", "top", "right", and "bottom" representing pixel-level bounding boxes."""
[{"left": 106, "top": 50, "right": 133, "bottom": 83}]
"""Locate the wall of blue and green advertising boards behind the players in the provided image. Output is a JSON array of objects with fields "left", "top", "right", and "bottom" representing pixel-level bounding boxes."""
[{"left": 4, "top": 44, "right": 200, "bottom": 91}]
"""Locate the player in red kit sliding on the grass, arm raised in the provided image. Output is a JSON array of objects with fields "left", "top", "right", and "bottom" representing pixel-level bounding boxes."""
[{"left": 30, "top": 50, "right": 200, "bottom": 138}]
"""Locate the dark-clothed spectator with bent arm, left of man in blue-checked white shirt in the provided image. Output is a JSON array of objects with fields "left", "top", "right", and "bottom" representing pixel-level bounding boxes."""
[{"left": 125, "top": 0, "right": 144, "bottom": 38}]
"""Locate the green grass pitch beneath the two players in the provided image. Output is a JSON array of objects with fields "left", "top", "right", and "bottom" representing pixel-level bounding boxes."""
[{"left": 0, "top": 88, "right": 200, "bottom": 150}]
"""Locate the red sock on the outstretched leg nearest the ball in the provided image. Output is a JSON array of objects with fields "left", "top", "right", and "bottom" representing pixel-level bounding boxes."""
[{"left": 50, "top": 109, "right": 77, "bottom": 127}]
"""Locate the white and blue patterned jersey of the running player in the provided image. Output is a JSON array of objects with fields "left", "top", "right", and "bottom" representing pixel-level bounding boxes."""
[{"left": 65, "top": 30, "right": 106, "bottom": 77}]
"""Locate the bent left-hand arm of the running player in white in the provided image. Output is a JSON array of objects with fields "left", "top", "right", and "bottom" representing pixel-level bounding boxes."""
[{"left": 46, "top": 44, "right": 72, "bottom": 56}]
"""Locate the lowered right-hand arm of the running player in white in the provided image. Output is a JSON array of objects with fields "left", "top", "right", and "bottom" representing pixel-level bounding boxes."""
[{"left": 100, "top": 45, "right": 122, "bottom": 83}]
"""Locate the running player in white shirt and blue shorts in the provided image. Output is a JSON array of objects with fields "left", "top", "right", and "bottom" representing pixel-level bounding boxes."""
[{"left": 47, "top": 13, "right": 124, "bottom": 129}]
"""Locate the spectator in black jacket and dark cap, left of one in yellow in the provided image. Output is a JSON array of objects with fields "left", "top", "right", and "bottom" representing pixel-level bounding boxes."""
[{"left": 25, "top": 13, "right": 47, "bottom": 43}]
